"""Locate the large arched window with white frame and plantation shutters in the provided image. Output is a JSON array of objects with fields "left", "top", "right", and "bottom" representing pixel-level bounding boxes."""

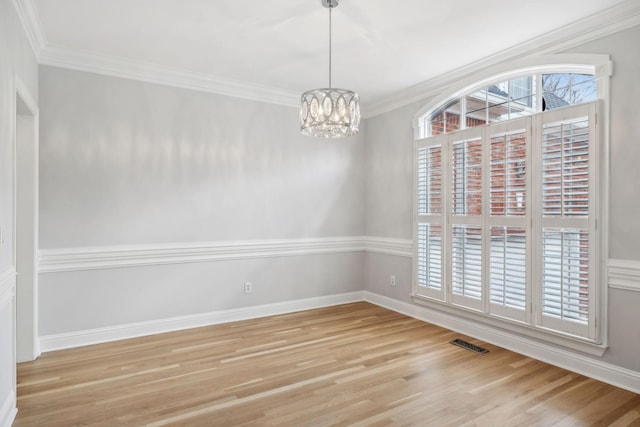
[{"left": 413, "top": 55, "right": 611, "bottom": 353}]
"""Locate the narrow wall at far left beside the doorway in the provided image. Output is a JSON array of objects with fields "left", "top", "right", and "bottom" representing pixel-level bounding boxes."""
[{"left": 0, "top": 0, "right": 38, "bottom": 423}]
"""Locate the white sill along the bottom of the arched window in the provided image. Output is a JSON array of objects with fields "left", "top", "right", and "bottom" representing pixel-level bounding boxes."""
[{"left": 411, "top": 294, "right": 608, "bottom": 357}]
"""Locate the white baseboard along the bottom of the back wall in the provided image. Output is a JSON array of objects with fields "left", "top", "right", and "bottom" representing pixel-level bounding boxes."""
[{"left": 40, "top": 291, "right": 363, "bottom": 351}]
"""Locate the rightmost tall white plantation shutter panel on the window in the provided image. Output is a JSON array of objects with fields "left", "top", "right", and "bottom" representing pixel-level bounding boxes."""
[{"left": 538, "top": 104, "right": 596, "bottom": 338}]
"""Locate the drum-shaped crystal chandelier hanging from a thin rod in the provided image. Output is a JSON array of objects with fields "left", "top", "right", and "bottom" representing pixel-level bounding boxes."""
[{"left": 300, "top": 0, "right": 360, "bottom": 138}]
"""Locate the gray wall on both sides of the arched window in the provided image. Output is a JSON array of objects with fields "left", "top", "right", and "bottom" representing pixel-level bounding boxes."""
[{"left": 365, "top": 27, "right": 640, "bottom": 371}]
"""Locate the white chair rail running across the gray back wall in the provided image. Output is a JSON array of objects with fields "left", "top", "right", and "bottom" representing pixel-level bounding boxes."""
[{"left": 39, "top": 236, "right": 366, "bottom": 273}]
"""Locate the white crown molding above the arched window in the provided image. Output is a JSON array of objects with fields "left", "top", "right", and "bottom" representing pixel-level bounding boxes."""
[{"left": 366, "top": 0, "right": 640, "bottom": 117}]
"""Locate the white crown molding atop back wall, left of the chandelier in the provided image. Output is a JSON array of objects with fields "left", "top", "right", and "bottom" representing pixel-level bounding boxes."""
[{"left": 40, "top": 45, "right": 300, "bottom": 107}]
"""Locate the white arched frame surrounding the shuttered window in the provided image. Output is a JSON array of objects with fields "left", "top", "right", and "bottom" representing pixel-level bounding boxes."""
[{"left": 411, "top": 55, "right": 612, "bottom": 355}]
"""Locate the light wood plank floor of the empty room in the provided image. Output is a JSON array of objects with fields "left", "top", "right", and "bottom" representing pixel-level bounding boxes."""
[{"left": 14, "top": 302, "right": 640, "bottom": 427}]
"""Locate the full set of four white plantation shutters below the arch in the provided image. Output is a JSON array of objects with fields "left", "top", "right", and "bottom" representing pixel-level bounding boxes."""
[{"left": 414, "top": 98, "right": 600, "bottom": 342}]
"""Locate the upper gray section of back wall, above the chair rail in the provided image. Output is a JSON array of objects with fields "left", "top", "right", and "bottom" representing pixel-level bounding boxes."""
[{"left": 40, "top": 66, "right": 364, "bottom": 249}]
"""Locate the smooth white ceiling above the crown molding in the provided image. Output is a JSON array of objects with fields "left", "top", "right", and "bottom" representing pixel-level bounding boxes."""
[{"left": 23, "top": 0, "right": 636, "bottom": 111}]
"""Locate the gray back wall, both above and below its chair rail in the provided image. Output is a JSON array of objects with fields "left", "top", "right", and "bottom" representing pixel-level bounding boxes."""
[{"left": 39, "top": 66, "right": 366, "bottom": 335}]
